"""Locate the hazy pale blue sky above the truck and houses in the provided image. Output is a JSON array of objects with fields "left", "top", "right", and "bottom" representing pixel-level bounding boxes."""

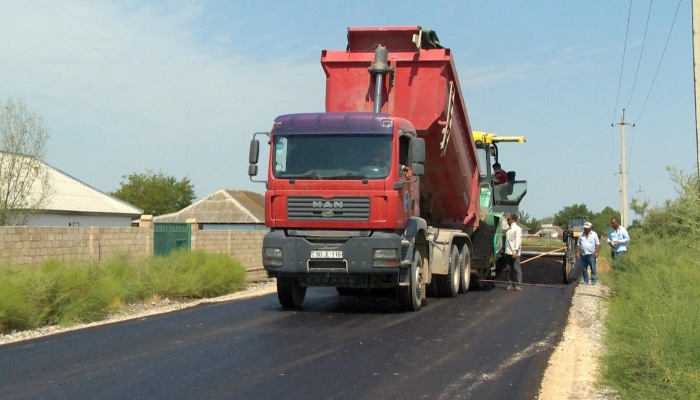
[{"left": 0, "top": 0, "right": 697, "bottom": 219}]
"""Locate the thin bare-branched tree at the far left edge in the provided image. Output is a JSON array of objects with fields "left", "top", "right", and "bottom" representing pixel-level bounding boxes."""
[{"left": 0, "top": 99, "right": 52, "bottom": 225}]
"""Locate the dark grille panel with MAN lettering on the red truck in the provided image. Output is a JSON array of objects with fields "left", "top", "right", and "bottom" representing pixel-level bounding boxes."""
[{"left": 287, "top": 197, "right": 369, "bottom": 221}]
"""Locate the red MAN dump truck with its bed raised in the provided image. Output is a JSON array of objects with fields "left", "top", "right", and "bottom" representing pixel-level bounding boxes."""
[{"left": 248, "top": 26, "right": 516, "bottom": 311}]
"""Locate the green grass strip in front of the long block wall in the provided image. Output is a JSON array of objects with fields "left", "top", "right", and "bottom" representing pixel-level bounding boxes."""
[{"left": 0, "top": 250, "right": 246, "bottom": 333}]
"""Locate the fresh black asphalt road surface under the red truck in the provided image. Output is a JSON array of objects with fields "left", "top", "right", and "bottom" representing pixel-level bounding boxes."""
[{"left": 0, "top": 262, "right": 573, "bottom": 400}]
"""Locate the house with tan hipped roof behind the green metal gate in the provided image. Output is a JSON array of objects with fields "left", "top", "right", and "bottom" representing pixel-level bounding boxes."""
[{"left": 153, "top": 189, "right": 267, "bottom": 230}]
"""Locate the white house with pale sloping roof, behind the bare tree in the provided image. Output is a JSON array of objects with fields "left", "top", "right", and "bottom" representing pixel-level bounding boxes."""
[{"left": 2, "top": 156, "right": 142, "bottom": 227}]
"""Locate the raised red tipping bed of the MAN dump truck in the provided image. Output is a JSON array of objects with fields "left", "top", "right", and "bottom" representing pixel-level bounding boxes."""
[{"left": 321, "top": 26, "right": 479, "bottom": 233}]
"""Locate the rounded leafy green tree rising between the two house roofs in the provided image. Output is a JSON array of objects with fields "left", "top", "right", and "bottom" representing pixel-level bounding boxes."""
[{"left": 110, "top": 170, "right": 195, "bottom": 215}]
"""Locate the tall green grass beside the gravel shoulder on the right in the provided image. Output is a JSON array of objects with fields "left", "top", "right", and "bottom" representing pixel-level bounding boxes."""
[{"left": 601, "top": 235, "right": 700, "bottom": 399}]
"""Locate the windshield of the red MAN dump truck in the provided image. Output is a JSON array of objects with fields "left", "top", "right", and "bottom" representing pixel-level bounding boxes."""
[{"left": 272, "top": 134, "right": 392, "bottom": 179}]
